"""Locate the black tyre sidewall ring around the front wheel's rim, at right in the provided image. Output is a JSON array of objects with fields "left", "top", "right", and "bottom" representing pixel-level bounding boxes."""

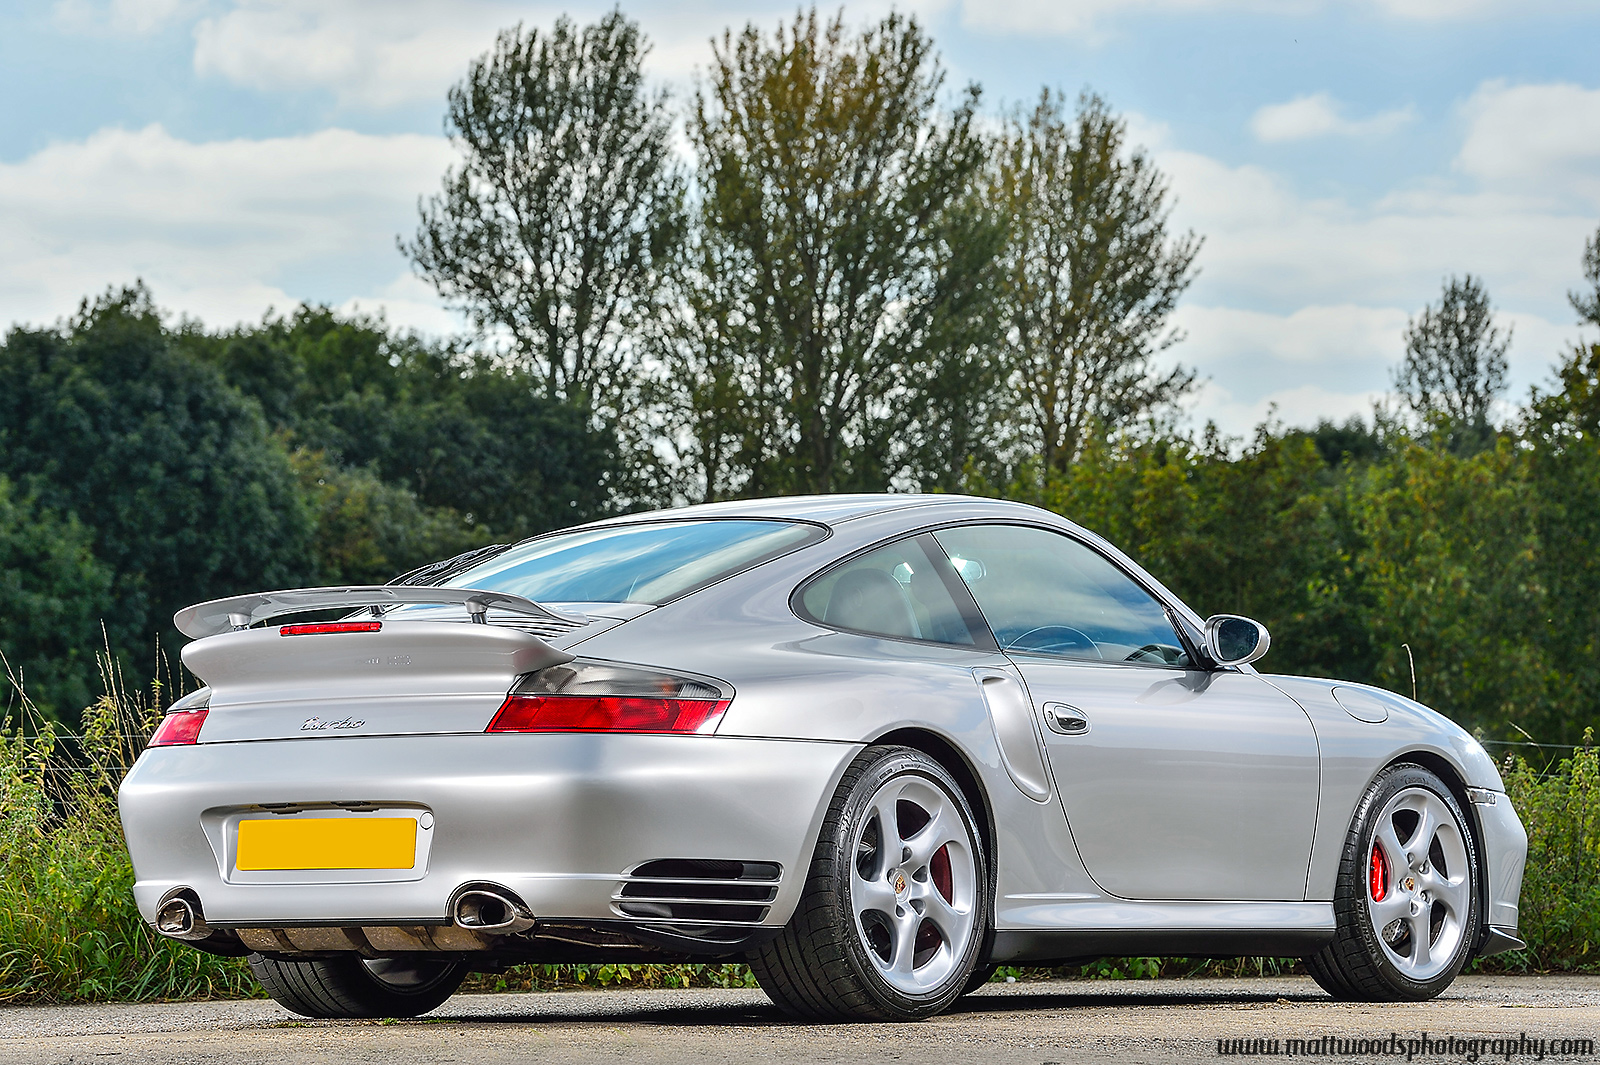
[{"left": 1347, "top": 764, "right": 1482, "bottom": 999}]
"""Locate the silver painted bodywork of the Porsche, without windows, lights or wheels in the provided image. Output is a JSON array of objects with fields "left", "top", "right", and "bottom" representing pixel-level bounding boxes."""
[{"left": 122, "top": 496, "right": 1526, "bottom": 958}]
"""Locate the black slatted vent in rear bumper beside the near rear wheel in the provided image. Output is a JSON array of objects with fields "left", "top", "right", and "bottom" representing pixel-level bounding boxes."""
[{"left": 611, "top": 859, "right": 782, "bottom": 924}]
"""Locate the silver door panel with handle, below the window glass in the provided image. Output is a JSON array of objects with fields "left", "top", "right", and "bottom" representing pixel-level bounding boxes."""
[{"left": 1013, "top": 656, "right": 1318, "bottom": 900}]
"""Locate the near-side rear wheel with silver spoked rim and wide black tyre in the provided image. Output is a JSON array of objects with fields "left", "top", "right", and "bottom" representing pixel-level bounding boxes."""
[{"left": 750, "top": 747, "right": 989, "bottom": 1020}]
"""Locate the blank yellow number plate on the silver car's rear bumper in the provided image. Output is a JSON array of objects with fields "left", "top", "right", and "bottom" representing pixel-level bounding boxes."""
[{"left": 234, "top": 817, "right": 416, "bottom": 870}]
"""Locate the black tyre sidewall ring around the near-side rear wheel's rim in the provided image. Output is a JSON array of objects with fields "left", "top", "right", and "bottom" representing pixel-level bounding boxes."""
[{"left": 829, "top": 747, "right": 990, "bottom": 1020}]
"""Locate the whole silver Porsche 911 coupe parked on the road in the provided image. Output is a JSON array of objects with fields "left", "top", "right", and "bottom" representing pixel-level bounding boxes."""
[{"left": 122, "top": 496, "right": 1526, "bottom": 1020}]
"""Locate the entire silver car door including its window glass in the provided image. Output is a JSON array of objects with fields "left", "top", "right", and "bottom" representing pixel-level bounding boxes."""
[{"left": 934, "top": 523, "right": 1318, "bottom": 902}]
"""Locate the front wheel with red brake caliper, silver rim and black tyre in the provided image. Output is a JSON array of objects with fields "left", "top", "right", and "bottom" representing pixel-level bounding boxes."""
[{"left": 1306, "top": 763, "right": 1482, "bottom": 1003}]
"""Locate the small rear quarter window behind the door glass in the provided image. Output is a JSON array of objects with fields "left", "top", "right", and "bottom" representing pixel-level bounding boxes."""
[{"left": 795, "top": 536, "right": 976, "bottom": 646}]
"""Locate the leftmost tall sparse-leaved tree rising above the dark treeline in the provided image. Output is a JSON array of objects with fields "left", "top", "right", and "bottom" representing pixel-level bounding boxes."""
[{"left": 400, "top": 11, "right": 683, "bottom": 416}]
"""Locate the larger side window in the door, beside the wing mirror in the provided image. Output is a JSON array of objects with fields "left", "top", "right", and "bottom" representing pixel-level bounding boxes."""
[{"left": 936, "top": 525, "right": 1189, "bottom": 667}]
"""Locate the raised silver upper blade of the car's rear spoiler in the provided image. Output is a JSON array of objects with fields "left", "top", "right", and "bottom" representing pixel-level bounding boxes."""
[{"left": 173, "top": 584, "right": 587, "bottom": 640}]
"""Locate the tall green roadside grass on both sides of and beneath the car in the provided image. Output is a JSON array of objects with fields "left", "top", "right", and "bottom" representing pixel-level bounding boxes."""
[{"left": 0, "top": 668, "right": 1600, "bottom": 1003}]
